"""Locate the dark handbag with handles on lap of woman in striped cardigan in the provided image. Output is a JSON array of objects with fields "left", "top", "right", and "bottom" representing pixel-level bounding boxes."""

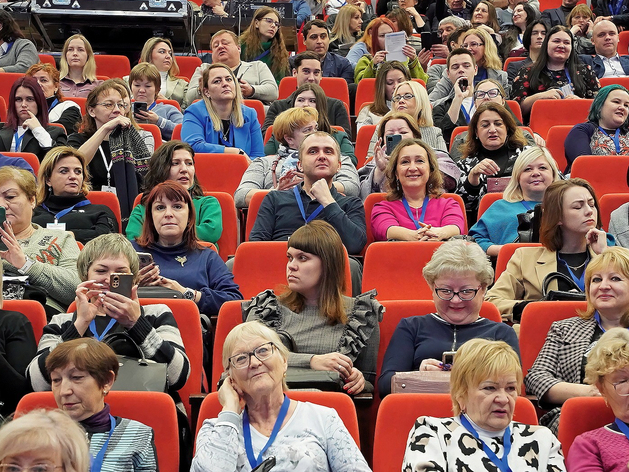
[{"left": 103, "top": 332, "right": 168, "bottom": 392}]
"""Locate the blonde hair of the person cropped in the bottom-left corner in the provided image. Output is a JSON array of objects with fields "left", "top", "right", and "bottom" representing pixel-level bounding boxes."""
[{"left": 0, "top": 409, "right": 90, "bottom": 472}]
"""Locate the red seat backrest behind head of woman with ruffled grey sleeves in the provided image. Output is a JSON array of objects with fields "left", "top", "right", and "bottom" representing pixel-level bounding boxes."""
[{"left": 232, "top": 241, "right": 352, "bottom": 300}]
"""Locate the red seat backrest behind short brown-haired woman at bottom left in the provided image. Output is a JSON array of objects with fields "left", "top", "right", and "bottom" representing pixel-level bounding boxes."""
[{"left": 15, "top": 391, "right": 179, "bottom": 472}]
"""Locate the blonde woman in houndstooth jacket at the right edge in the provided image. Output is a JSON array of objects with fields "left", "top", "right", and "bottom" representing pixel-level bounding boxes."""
[{"left": 524, "top": 247, "right": 629, "bottom": 434}]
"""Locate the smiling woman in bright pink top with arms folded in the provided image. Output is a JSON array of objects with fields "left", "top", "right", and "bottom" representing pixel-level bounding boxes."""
[{"left": 371, "top": 138, "right": 465, "bottom": 241}]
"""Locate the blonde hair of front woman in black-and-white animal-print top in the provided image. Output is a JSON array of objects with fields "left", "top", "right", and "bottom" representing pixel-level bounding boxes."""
[{"left": 450, "top": 338, "right": 523, "bottom": 415}]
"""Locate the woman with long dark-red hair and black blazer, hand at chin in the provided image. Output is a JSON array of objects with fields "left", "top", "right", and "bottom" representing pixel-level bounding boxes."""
[{"left": 0, "top": 77, "right": 67, "bottom": 161}]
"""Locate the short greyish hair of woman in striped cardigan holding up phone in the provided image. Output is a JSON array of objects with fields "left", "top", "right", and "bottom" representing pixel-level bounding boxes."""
[{"left": 76, "top": 233, "right": 140, "bottom": 282}]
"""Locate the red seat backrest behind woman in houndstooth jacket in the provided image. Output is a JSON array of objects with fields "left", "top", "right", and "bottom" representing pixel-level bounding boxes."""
[{"left": 519, "top": 301, "right": 587, "bottom": 375}]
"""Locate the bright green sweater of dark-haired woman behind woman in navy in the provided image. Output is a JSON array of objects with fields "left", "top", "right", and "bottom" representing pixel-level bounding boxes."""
[{"left": 127, "top": 196, "right": 223, "bottom": 244}]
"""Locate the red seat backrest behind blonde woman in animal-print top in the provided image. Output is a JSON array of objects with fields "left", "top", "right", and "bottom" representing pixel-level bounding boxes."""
[{"left": 373, "top": 393, "right": 537, "bottom": 472}]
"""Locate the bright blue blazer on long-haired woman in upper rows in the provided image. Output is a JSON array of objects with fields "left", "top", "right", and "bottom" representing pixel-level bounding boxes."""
[{"left": 181, "top": 100, "right": 264, "bottom": 159}]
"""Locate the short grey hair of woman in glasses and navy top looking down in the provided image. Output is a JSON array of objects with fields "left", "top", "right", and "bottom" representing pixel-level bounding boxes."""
[{"left": 422, "top": 239, "right": 494, "bottom": 287}]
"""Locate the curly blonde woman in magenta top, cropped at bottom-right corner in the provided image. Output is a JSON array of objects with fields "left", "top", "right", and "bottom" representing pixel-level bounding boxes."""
[{"left": 566, "top": 326, "right": 629, "bottom": 470}]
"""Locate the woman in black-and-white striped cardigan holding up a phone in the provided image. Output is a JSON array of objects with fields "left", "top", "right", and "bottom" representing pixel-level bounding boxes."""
[{"left": 26, "top": 234, "right": 190, "bottom": 392}]
